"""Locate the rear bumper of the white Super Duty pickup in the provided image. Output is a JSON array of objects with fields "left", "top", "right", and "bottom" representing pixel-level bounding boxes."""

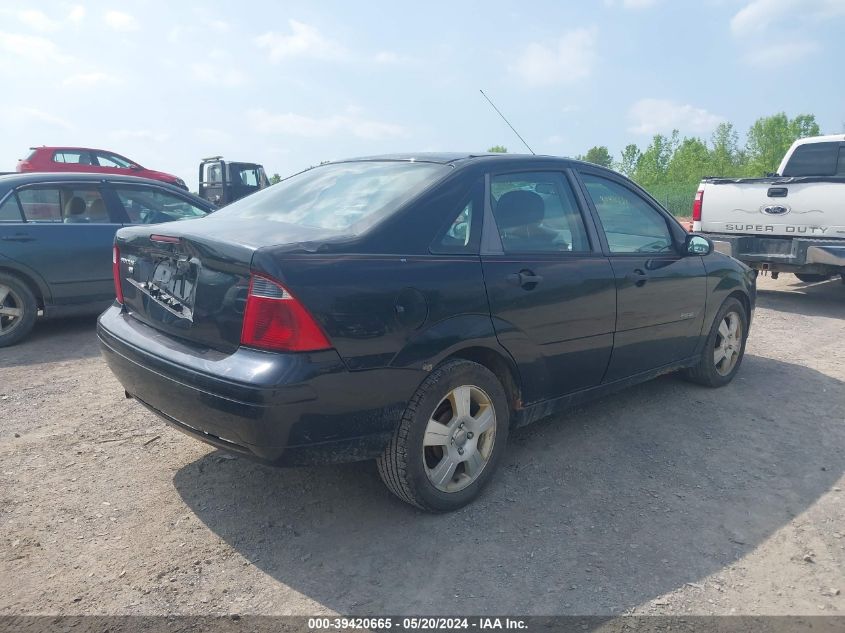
[{"left": 705, "top": 233, "right": 845, "bottom": 273}]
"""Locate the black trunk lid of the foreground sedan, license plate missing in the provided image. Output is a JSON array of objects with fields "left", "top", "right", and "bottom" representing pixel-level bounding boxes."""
[{"left": 115, "top": 214, "right": 350, "bottom": 352}]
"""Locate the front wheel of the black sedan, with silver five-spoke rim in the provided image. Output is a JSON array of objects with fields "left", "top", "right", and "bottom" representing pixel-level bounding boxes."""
[{"left": 685, "top": 297, "right": 748, "bottom": 387}]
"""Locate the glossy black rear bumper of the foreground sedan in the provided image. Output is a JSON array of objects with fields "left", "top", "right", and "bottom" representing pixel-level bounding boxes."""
[{"left": 97, "top": 306, "right": 419, "bottom": 465}]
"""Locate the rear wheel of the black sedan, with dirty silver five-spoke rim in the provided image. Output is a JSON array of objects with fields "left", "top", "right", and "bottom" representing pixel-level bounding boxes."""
[{"left": 377, "top": 360, "right": 510, "bottom": 512}]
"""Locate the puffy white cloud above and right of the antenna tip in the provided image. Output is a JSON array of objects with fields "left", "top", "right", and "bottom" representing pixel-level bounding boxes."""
[{"left": 510, "top": 28, "right": 596, "bottom": 86}]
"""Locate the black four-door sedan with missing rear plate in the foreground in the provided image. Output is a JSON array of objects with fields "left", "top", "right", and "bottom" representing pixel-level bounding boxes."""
[{"left": 97, "top": 155, "right": 755, "bottom": 511}]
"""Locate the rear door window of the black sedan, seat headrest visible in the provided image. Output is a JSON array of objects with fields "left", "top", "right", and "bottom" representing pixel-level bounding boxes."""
[{"left": 490, "top": 172, "right": 590, "bottom": 253}]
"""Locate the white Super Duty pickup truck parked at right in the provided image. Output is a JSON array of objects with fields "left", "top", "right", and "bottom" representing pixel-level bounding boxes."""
[{"left": 692, "top": 134, "right": 845, "bottom": 283}]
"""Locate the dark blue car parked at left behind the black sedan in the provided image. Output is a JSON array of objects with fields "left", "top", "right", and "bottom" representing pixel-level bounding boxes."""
[{"left": 0, "top": 173, "right": 214, "bottom": 347}]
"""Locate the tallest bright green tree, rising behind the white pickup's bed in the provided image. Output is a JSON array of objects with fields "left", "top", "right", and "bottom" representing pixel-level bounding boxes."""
[{"left": 745, "top": 112, "right": 819, "bottom": 176}]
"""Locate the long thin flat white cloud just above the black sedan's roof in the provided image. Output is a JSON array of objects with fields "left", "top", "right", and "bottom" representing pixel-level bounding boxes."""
[{"left": 247, "top": 108, "right": 406, "bottom": 141}]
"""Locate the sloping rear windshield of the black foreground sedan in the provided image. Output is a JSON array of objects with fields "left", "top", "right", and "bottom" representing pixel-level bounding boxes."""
[{"left": 208, "top": 161, "right": 450, "bottom": 234}]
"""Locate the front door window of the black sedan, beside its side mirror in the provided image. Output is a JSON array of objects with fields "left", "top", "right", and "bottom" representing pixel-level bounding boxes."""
[{"left": 581, "top": 174, "right": 675, "bottom": 254}]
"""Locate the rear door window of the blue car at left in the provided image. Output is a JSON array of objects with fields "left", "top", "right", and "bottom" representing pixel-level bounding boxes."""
[{"left": 18, "top": 186, "right": 111, "bottom": 224}]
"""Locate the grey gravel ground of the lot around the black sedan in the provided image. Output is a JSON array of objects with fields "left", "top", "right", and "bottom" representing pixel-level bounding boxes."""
[{"left": 0, "top": 275, "right": 845, "bottom": 615}]
